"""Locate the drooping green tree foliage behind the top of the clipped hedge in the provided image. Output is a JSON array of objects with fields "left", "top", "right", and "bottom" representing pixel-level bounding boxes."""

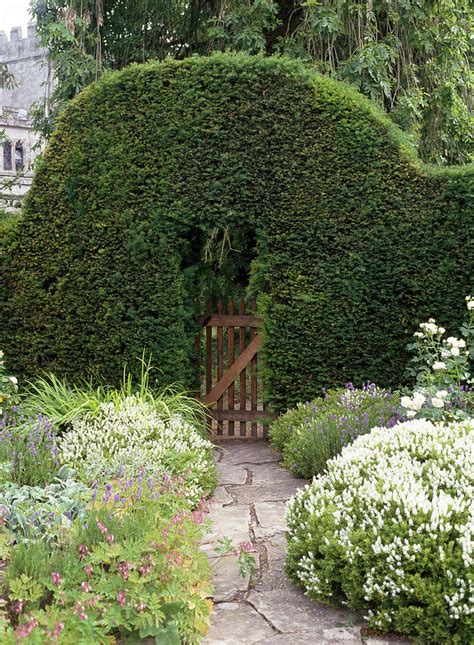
[{"left": 31, "top": 0, "right": 474, "bottom": 164}]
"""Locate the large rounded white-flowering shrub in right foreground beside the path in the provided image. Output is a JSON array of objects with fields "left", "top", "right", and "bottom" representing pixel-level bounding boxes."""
[{"left": 286, "top": 419, "right": 474, "bottom": 643}]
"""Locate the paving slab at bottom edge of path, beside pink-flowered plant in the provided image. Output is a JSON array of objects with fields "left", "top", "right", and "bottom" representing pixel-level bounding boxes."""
[{"left": 203, "top": 602, "right": 275, "bottom": 645}]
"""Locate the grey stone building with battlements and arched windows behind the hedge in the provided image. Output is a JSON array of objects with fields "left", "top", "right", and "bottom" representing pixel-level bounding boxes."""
[{"left": 0, "top": 24, "right": 52, "bottom": 207}]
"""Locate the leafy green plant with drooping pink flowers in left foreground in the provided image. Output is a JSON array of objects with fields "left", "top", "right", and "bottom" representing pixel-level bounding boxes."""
[{"left": 0, "top": 476, "right": 212, "bottom": 645}]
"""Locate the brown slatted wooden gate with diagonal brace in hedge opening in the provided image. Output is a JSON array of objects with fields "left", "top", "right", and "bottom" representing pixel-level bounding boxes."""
[{"left": 196, "top": 300, "right": 272, "bottom": 438}]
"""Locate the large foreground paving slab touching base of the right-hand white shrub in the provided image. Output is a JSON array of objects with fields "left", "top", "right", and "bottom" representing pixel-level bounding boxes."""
[{"left": 248, "top": 587, "right": 360, "bottom": 634}]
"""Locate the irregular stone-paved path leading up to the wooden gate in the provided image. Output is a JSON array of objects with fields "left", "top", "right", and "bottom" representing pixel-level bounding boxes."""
[{"left": 202, "top": 441, "right": 407, "bottom": 645}]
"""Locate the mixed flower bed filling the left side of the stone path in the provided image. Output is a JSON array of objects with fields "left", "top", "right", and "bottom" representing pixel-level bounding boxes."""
[{"left": 0, "top": 354, "right": 218, "bottom": 645}]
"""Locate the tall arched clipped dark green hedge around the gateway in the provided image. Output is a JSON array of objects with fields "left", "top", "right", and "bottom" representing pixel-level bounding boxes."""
[{"left": 1, "top": 55, "right": 474, "bottom": 408}]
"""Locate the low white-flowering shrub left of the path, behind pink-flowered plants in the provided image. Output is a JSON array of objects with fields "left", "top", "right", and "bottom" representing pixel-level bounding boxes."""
[{"left": 59, "top": 396, "right": 216, "bottom": 503}]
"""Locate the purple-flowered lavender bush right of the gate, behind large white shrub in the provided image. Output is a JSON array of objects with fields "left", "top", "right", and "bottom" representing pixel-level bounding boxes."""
[{"left": 270, "top": 383, "right": 399, "bottom": 479}]
